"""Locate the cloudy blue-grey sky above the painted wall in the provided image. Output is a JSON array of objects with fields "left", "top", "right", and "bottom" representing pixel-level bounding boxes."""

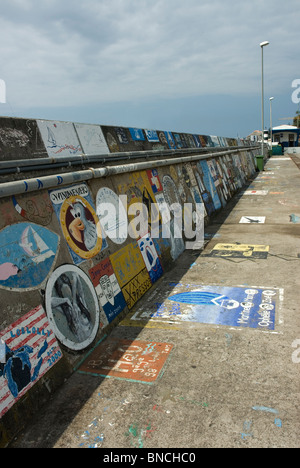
[{"left": 0, "top": 0, "right": 300, "bottom": 137}]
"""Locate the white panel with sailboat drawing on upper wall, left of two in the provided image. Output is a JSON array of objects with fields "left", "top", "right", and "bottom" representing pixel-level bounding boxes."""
[{"left": 37, "top": 120, "right": 83, "bottom": 157}]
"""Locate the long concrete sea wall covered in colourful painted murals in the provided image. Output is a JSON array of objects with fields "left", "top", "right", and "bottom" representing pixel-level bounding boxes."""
[{"left": 0, "top": 118, "right": 259, "bottom": 447}]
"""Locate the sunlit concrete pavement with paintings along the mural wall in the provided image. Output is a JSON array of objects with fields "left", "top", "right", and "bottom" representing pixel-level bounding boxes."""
[{"left": 11, "top": 155, "right": 300, "bottom": 449}]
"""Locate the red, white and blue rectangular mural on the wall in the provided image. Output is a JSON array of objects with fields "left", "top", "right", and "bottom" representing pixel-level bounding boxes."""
[{"left": 89, "top": 258, "right": 126, "bottom": 323}]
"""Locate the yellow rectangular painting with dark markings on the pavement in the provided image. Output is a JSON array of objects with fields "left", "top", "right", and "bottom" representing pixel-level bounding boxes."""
[{"left": 208, "top": 244, "right": 270, "bottom": 259}]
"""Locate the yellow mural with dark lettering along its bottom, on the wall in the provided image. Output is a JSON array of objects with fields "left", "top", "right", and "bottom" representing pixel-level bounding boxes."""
[{"left": 110, "top": 242, "right": 152, "bottom": 309}]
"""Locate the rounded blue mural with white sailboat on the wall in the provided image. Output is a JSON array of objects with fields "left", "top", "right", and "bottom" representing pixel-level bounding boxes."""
[{"left": 0, "top": 223, "right": 59, "bottom": 290}]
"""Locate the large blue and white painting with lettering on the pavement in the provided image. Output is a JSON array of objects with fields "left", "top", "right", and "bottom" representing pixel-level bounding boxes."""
[{"left": 131, "top": 283, "right": 278, "bottom": 330}]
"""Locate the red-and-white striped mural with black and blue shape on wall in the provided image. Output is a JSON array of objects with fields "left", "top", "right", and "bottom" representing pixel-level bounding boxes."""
[{"left": 0, "top": 306, "right": 62, "bottom": 418}]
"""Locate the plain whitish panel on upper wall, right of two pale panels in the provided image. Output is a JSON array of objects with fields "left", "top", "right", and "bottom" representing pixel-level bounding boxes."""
[{"left": 74, "top": 123, "right": 110, "bottom": 154}]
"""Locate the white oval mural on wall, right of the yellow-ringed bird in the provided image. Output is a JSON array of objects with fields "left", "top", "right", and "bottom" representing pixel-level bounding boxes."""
[{"left": 96, "top": 187, "right": 128, "bottom": 244}]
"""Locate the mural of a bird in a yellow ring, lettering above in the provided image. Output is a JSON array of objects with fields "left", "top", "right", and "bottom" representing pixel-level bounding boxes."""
[{"left": 49, "top": 183, "right": 107, "bottom": 265}]
